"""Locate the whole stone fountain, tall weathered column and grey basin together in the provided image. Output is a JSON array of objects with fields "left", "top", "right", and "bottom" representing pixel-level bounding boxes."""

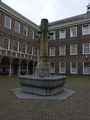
[{"left": 19, "top": 19, "right": 66, "bottom": 96}]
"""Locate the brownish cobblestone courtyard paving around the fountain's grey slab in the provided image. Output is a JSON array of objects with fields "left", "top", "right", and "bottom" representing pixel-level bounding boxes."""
[{"left": 0, "top": 76, "right": 90, "bottom": 120}]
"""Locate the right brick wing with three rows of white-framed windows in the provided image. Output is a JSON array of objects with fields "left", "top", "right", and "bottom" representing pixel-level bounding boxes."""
[{"left": 49, "top": 5, "right": 90, "bottom": 75}]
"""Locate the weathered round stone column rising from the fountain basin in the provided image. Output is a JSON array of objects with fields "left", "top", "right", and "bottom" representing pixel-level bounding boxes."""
[{"left": 39, "top": 19, "right": 50, "bottom": 77}]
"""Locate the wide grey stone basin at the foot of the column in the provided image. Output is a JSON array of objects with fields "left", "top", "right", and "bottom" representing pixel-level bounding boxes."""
[{"left": 19, "top": 75, "right": 66, "bottom": 96}]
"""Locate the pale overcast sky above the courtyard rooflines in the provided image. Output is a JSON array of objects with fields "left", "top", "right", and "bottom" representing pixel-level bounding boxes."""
[{"left": 2, "top": 0, "right": 89, "bottom": 24}]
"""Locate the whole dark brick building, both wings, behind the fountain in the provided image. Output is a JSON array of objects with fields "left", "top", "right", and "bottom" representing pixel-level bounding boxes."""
[{"left": 0, "top": 1, "right": 90, "bottom": 76}]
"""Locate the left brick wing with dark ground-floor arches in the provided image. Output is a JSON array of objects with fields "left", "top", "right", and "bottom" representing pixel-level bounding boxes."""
[{"left": 0, "top": 2, "right": 38, "bottom": 76}]
